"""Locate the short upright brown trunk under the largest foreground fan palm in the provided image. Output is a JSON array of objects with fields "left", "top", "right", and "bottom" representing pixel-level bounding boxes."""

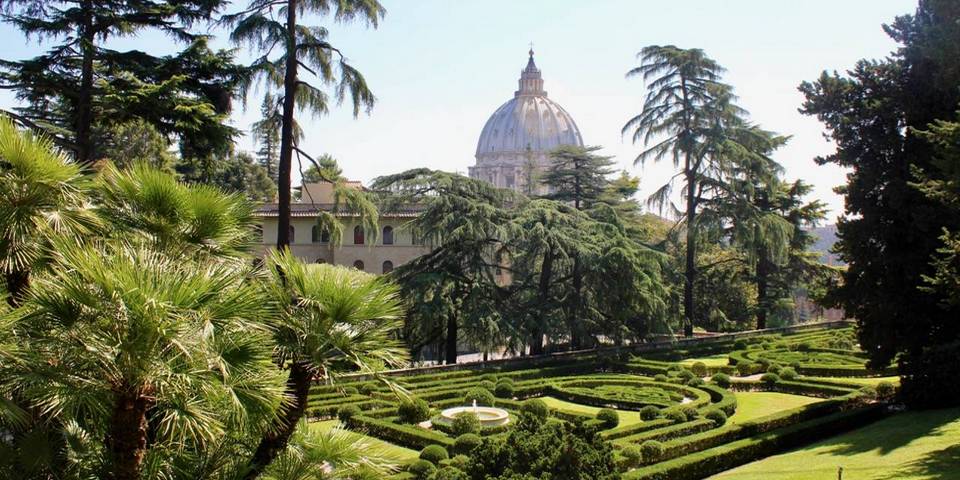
[{"left": 106, "top": 392, "right": 152, "bottom": 480}]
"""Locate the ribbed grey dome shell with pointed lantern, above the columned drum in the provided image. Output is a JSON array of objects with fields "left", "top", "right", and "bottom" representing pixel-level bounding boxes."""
[{"left": 477, "top": 50, "right": 583, "bottom": 164}]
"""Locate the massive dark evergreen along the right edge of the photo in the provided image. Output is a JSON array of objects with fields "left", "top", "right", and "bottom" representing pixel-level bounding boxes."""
[{"left": 800, "top": 0, "right": 960, "bottom": 405}]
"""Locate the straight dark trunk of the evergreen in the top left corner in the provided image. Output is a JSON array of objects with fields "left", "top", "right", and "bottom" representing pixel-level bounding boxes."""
[{"left": 73, "top": 0, "right": 96, "bottom": 166}]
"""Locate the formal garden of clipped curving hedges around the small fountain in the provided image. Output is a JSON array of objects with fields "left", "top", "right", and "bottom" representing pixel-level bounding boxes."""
[{"left": 308, "top": 328, "right": 894, "bottom": 479}]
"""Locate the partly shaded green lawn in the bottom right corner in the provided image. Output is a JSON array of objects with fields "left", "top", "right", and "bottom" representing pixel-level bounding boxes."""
[{"left": 710, "top": 408, "right": 960, "bottom": 480}]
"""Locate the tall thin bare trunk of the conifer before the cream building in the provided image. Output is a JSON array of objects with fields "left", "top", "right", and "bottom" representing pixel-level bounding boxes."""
[{"left": 277, "top": 0, "right": 298, "bottom": 251}]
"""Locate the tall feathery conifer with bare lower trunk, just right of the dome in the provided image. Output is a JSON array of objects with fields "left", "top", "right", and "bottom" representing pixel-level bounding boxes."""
[{"left": 622, "top": 45, "right": 741, "bottom": 336}]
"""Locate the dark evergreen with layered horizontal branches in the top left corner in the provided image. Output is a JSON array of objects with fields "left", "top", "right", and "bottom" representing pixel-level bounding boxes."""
[{"left": 0, "top": 0, "right": 229, "bottom": 164}]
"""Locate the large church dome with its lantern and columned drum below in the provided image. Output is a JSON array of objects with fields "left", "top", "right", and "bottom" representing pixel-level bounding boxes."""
[{"left": 470, "top": 50, "right": 583, "bottom": 195}]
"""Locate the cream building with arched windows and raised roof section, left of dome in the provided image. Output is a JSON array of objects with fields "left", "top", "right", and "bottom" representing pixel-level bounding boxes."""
[{"left": 256, "top": 182, "right": 429, "bottom": 274}]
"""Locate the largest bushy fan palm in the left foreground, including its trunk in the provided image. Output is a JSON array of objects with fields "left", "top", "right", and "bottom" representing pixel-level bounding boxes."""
[{"left": 16, "top": 241, "right": 283, "bottom": 480}]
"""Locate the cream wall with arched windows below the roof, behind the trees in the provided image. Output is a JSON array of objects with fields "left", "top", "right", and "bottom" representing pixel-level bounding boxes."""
[{"left": 255, "top": 217, "right": 429, "bottom": 273}]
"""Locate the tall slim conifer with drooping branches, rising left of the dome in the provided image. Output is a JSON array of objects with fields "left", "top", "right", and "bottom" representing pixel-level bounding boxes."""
[{"left": 224, "top": 0, "right": 386, "bottom": 250}]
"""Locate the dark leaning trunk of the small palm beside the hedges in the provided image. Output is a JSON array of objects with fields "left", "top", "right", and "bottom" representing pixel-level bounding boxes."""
[{"left": 243, "top": 362, "right": 313, "bottom": 480}]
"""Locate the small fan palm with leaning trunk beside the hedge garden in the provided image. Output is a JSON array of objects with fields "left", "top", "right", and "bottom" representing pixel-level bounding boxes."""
[{"left": 245, "top": 251, "right": 407, "bottom": 479}]
